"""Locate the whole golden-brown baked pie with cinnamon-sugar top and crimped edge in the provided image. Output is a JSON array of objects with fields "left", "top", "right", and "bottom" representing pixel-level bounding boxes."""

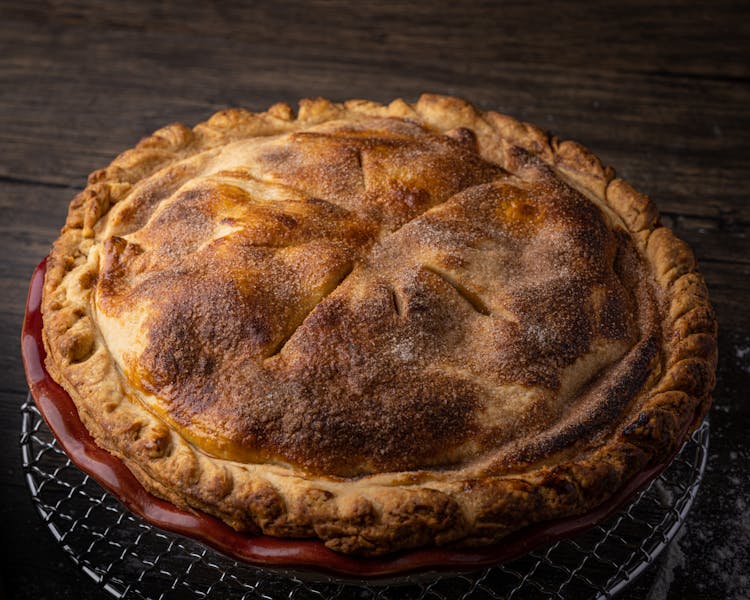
[{"left": 42, "top": 95, "right": 716, "bottom": 556}]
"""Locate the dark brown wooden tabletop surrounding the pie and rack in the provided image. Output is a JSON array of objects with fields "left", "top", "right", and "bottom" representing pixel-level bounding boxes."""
[{"left": 0, "top": 0, "right": 750, "bottom": 599}]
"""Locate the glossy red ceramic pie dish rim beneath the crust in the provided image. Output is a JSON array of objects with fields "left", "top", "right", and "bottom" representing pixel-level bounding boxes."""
[{"left": 22, "top": 259, "right": 704, "bottom": 579}]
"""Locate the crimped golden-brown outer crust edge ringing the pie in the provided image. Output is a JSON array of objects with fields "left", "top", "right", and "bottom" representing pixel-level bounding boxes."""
[{"left": 43, "top": 95, "right": 716, "bottom": 555}]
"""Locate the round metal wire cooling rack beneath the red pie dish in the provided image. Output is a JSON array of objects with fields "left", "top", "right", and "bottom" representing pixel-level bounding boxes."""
[{"left": 21, "top": 397, "right": 709, "bottom": 600}]
